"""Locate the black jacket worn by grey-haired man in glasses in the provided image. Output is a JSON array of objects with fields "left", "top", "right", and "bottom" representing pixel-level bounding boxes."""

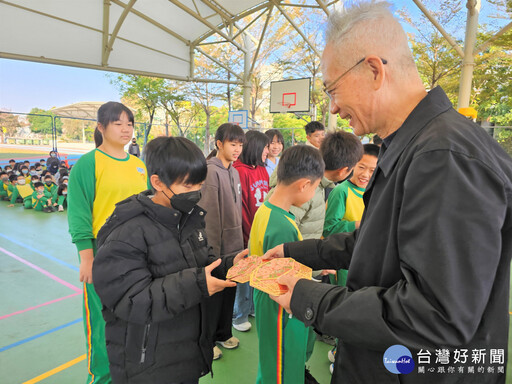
[{"left": 285, "top": 88, "right": 512, "bottom": 384}]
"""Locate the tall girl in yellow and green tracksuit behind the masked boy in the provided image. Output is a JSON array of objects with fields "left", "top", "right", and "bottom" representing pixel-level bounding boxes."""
[{"left": 68, "top": 102, "right": 147, "bottom": 384}]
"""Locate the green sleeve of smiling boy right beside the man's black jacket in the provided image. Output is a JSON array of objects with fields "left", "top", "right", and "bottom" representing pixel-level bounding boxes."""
[{"left": 323, "top": 185, "right": 356, "bottom": 237}]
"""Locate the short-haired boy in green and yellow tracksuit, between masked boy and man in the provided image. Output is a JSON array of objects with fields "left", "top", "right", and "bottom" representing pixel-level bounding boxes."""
[{"left": 249, "top": 145, "right": 324, "bottom": 384}]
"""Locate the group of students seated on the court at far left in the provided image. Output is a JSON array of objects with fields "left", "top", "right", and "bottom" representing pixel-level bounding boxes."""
[{"left": 0, "top": 155, "right": 69, "bottom": 212}]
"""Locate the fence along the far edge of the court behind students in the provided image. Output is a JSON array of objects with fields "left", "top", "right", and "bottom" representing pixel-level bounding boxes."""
[{"left": 0, "top": 112, "right": 512, "bottom": 156}]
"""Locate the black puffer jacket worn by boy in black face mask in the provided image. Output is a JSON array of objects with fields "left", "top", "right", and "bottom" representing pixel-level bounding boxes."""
[{"left": 93, "top": 191, "right": 233, "bottom": 384}]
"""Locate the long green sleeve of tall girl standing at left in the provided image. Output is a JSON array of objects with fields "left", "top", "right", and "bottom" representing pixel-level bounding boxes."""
[{"left": 68, "top": 151, "right": 96, "bottom": 251}]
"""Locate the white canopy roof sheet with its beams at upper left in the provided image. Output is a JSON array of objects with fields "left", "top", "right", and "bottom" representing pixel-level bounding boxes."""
[{"left": 0, "top": 0, "right": 328, "bottom": 83}]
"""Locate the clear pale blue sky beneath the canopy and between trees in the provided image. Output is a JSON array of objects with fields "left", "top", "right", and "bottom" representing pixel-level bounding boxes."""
[{"left": 0, "top": 0, "right": 504, "bottom": 113}]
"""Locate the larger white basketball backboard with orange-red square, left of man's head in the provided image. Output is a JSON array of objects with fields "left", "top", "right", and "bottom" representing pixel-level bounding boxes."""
[{"left": 270, "top": 77, "right": 311, "bottom": 113}]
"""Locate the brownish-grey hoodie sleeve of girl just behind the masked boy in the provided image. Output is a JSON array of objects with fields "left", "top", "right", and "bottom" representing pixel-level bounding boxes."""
[{"left": 198, "top": 170, "right": 222, "bottom": 257}]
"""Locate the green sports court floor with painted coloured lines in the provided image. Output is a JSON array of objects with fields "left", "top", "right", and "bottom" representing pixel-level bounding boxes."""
[{"left": 0, "top": 202, "right": 512, "bottom": 384}]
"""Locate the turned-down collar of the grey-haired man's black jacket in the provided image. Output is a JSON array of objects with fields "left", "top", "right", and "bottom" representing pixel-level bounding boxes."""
[{"left": 376, "top": 87, "right": 452, "bottom": 178}]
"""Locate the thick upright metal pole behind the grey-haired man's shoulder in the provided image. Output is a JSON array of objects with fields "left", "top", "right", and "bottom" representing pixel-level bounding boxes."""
[{"left": 458, "top": 0, "right": 481, "bottom": 108}]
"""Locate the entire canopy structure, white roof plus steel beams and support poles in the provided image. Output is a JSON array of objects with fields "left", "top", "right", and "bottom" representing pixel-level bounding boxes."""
[{"left": 0, "top": 0, "right": 512, "bottom": 109}]
